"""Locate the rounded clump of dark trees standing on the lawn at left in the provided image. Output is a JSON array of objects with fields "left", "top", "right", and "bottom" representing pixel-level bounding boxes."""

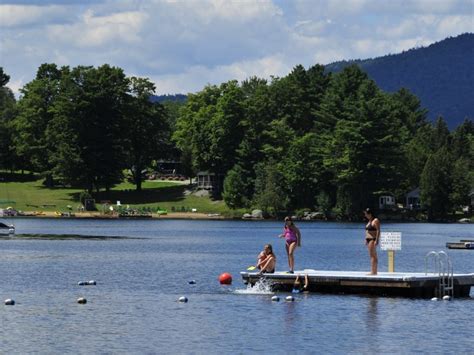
[{"left": 12, "top": 64, "right": 169, "bottom": 192}]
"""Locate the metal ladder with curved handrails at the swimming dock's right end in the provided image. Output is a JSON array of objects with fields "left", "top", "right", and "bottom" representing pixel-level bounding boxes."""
[{"left": 425, "top": 250, "right": 454, "bottom": 299}]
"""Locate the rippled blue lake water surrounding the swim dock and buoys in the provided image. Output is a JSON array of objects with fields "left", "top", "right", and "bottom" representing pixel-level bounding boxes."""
[{"left": 0, "top": 219, "right": 474, "bottom": 354}]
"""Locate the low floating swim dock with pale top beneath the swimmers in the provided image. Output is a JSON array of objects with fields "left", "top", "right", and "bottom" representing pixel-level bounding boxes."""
[{"left": 240, "top": 269, "right": 474, "bottom": 298}]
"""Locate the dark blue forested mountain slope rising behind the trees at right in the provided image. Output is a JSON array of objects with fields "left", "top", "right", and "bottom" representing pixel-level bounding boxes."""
[{"left": 326, "top": 33, "right": 474, "bottom": 129}]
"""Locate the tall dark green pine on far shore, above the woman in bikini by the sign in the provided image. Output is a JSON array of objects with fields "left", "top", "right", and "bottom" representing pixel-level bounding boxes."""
[{"left": 320, "top": 66, "right": 406, "bottom": 215}]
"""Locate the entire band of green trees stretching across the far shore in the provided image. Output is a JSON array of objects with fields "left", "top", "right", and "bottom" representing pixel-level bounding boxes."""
[{"left": 0, "top": 64, "right": 474, "bottom": 219}]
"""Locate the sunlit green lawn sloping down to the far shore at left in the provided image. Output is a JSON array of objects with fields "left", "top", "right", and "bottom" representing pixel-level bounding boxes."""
[{"left": 0, "top": 180, "right": 239, "bottom": 215}]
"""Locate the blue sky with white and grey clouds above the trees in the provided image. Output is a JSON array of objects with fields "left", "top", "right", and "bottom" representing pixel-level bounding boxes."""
[{"left": 0, "top": 0, "right": 474, "bottom": 94}]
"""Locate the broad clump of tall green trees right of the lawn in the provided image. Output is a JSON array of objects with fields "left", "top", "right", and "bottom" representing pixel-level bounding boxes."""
[{"left": 174, "top": 61, "right": 470, "bottom": 217}]
